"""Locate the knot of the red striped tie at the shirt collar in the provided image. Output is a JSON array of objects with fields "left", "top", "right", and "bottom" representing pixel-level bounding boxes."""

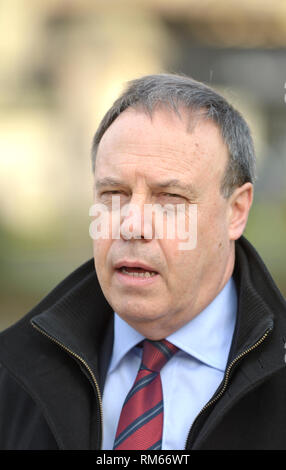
[{"left": 141, "top": 339, "right": 178, "bottom": 372}]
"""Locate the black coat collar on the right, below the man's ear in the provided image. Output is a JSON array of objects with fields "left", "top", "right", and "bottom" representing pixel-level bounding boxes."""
[{"left": 188, "top": 237, "right": 286, "bottom": 449}]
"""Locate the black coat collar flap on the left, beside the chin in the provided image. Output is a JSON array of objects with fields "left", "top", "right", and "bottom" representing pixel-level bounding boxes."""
[{"left": 31, "top": 259, "right": 113, "bottom": 388}]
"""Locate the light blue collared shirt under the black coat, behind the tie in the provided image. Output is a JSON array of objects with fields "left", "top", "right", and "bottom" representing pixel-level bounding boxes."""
[{"left": 102, "top": 278, "right": 237, "bottom": 450}]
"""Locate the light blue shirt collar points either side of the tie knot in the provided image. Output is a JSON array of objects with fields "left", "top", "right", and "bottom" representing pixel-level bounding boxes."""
[{"left": 109, "top": 278, "right": 237, "bottom": 372}]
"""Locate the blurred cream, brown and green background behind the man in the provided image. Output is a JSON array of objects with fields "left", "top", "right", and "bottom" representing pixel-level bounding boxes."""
[{"left": 0, "top": 0, "right": 286, "bottom": 330}]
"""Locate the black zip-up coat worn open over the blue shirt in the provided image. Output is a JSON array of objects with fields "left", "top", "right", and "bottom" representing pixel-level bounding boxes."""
[{"left": 0, "top": 237, "right": 286, "bottom": 450}]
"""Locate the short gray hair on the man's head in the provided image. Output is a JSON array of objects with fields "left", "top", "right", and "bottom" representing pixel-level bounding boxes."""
[{"left": 92, "top": 74, "right": 255, "bottom": 198}]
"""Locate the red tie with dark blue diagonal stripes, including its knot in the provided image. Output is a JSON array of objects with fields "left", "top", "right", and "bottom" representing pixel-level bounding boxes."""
[{"left": 113, "top": 339, "right": 178, "bottom": 450}]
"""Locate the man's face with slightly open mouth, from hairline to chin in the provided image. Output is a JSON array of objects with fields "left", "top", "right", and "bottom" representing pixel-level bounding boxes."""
[{"left": 93, "top": 109, "right": 236, "bottom": 340}]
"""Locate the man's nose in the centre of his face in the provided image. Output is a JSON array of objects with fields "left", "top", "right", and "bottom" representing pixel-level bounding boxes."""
[{"left": 120, "top": 194, "right": 153, "bottom": 240}]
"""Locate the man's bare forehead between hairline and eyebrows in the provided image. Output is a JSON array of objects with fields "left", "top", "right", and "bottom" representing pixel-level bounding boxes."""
[{"left": 95, "top": 108, "right": 228, "bottom": 186}]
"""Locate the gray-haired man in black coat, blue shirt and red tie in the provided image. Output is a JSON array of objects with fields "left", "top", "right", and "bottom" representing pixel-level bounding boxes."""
[{"left": 0, "top": 74, "right": 286, "bottom": 450}]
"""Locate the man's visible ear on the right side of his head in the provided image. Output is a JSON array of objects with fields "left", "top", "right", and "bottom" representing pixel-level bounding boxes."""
[{"left": 228, "top": 183, "right": 253, "bottom": 240}]
